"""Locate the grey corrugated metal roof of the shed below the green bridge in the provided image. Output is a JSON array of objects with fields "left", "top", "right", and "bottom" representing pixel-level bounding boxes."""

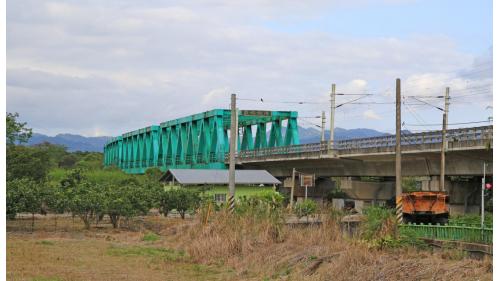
[{"left": 161, "top": 169, "right": 281, "bottom": 185}]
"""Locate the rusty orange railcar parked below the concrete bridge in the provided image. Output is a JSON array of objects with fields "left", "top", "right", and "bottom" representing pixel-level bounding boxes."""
[{"left": 402, "top": 191, "right": 450, "bottom": 224}]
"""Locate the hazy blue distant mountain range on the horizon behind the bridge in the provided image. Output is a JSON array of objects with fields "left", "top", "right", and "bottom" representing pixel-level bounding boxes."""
[{"left": 28, "top": 126, "right": 389, "bottom": 152}]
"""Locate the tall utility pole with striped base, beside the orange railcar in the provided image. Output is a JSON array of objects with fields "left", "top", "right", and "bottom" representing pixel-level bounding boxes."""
[{"left": 396, "top": 78, "right": 403, "bottom": 224}]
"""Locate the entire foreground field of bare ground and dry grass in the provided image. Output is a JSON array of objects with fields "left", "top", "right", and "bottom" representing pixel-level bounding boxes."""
[{"left": 7, "top": 212, "right": 492, "bottom": 280}]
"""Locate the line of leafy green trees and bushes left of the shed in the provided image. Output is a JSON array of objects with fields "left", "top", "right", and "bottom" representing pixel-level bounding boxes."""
[{"left": 6, "top": 113, "right": 203, "bottom": 229}]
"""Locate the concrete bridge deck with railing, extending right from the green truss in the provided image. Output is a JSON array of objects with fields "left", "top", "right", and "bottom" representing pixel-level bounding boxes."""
[{"left": 237, "top": 126, "right": 493, "bottom": 177}]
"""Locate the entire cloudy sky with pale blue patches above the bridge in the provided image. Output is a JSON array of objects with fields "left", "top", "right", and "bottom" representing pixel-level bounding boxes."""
[{"left": 7, "top": 0, "right": 493, "bottom": 136}]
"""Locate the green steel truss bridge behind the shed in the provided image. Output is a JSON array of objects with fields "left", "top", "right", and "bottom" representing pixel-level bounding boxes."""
[{"left": 104, "top": 109, "right": 299, "bottom": 174}]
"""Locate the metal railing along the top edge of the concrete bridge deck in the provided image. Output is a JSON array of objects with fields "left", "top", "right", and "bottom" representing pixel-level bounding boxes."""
[{"left": 234, "top": 126, "right": 493, "bottom": 159}]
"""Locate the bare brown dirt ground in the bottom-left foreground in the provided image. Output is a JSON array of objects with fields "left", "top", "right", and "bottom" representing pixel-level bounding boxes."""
[{"left": 7, "top": 215, "right": 234, "bottom": 281}]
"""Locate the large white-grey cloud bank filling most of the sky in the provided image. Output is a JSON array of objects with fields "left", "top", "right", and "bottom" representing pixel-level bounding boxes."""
[{"left": 7, "top": 0, "right": 488, "bottom": 135}]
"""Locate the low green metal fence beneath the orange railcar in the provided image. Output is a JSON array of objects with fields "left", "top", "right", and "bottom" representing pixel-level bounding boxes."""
[{"left": 399, "top": 224, "right": 493, "bottom": 244}]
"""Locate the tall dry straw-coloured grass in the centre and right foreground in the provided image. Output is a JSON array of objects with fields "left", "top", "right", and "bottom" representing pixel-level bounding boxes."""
[{"left": 178, "top": 203, "right": 492, "bottom": 280}]
